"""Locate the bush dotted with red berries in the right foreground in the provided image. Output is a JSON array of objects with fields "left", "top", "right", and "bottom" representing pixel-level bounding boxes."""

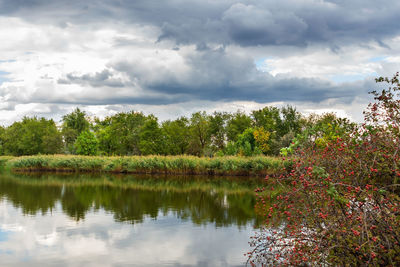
[{"left": 249, "top": 74, "right": 400, "bottom": 266}]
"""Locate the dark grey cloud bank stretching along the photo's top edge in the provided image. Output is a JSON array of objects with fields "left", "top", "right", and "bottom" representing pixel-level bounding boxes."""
[{"left": 0, "top": 0, "right": 400, "bottom": 46}]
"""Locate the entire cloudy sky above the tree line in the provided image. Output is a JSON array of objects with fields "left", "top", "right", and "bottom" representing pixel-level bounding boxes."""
[{"left": 0, "top": 0, "right": 400, "bottom": 125}]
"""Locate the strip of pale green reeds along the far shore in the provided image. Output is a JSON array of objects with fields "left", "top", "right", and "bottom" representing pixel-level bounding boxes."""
[{"left": 4, "top": 155, "right": 284, "bottom": 176}]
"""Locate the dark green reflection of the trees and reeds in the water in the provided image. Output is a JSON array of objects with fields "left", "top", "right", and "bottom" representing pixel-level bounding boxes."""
[{"left": 0, "top": 172, "right": 262, "bottom": 228}]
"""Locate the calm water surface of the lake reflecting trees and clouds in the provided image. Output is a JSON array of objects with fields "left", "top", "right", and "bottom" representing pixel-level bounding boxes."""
[{"left": 0, "top": 172, "right": 260, "bottom": 266}]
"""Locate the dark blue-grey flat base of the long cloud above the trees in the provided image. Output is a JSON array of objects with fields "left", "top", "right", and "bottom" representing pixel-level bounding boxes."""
[{"left": 145, "top": 77, "right": 373, "bottom": 103}]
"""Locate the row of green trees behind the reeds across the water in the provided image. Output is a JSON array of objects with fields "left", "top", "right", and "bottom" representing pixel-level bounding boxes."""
[{"left": 0, "top": 106, "right": 350, "bottom": 156}]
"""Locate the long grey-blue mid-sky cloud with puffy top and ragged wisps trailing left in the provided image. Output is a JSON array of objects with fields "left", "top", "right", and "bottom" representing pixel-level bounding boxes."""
[{"left": 53, "top": 49, "right": 373, "bottom": 104}]
